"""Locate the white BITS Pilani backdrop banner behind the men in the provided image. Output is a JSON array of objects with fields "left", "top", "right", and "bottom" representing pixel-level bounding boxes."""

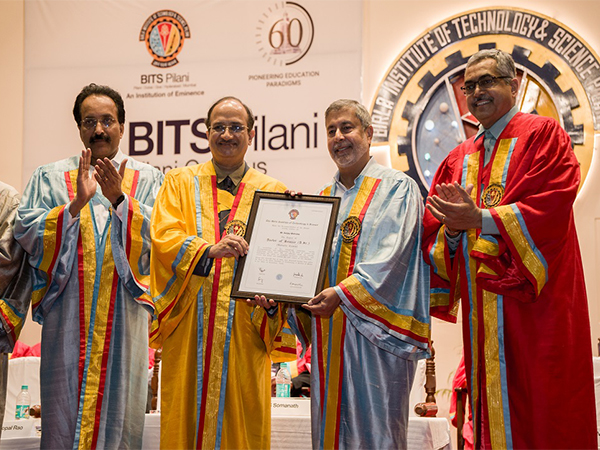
[{"left": 23, "top": 0, "right": 362, "bottom": 192}]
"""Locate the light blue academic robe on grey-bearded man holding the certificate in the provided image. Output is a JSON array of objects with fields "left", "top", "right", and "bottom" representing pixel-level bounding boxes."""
[{"left": 291, "top": 160, "right": 430, "bottom": 449}]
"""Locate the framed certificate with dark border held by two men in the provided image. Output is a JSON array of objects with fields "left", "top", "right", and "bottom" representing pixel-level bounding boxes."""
[{"left": 231, "top": 192, "right": 340, "bottom": 303}]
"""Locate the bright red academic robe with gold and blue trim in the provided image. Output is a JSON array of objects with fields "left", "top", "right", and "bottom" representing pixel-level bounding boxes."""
[{"left": 423, "top": 113, "right": 597, "bottom": 449}]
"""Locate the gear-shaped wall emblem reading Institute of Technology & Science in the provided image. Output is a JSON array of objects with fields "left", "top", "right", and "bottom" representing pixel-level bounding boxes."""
[{"left": 371, "top": 8, "right": 600, "bottom": 195}]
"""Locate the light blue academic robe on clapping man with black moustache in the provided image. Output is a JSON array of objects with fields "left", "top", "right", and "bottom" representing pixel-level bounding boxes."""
[{"left": 15, "top": 156, "right": 163, "bottom": 449}]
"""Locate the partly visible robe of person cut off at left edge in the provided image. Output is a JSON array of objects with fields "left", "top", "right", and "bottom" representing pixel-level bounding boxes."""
[{"left": 0, "top": 182, "right": 32, "bottom": 433}]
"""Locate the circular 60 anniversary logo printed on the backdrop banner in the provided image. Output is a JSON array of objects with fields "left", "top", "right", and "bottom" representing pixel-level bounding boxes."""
[{"left": 256, "top": 2, "right": 314, "bottom": 66}]
